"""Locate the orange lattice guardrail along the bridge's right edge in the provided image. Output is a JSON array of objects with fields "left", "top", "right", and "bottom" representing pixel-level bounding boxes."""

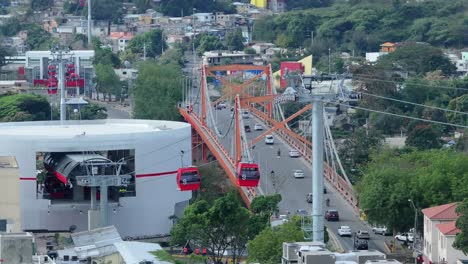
[{"left": 252, "top": 110, "right": 359, "bottom": 212}]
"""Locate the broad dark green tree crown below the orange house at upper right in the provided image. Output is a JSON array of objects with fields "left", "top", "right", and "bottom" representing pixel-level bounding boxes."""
[{"left": 377, "top": 43, "right": 455, "bottom": 75}]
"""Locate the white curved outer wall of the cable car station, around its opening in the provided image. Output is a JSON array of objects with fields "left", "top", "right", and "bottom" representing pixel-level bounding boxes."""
[{"left": 0, "top": 120, "right": 192, "bottom": 238}]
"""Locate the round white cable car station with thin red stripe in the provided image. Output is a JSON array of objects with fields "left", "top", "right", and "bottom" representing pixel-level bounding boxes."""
[{"left": 0, "top": 119, "right": 192, "bottom": 238}]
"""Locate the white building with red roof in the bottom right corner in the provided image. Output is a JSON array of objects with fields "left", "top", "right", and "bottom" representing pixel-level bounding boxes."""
[{"left": 422, "top": 203, "right": 468, "bottom": 264}]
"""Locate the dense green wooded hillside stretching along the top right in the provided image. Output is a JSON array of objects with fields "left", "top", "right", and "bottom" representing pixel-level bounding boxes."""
[{"left": 253, "top": 0, "right": 468, "bottom": 55}]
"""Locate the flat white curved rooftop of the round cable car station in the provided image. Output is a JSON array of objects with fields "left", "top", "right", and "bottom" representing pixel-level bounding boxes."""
[{"left": 0, "top": 119, "right": 190, "bottom": 138}]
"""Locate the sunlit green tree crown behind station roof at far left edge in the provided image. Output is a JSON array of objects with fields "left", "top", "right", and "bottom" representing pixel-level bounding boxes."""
[{"left": 0, "top": 94, "right": 50, "bottom": 122}]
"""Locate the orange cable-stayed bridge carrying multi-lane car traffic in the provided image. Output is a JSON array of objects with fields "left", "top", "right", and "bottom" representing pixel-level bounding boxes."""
[{"left": 179, "top": 65, "right": 384, "bottom": 253}]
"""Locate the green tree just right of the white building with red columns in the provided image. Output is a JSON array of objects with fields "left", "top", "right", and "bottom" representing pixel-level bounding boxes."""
[{"left": 95, "top": 63, "right": 122, "bottom": 101}]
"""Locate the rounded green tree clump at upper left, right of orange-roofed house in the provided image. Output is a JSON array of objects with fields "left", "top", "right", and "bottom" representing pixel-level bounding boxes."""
[{"left": 128, "top": 29, "right": 167, "bottom": 58}]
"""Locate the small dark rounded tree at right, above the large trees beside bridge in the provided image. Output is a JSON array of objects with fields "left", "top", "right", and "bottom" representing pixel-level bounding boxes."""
[{"left": 405, "top": 125, "right": 441, "bottom": 150}]
